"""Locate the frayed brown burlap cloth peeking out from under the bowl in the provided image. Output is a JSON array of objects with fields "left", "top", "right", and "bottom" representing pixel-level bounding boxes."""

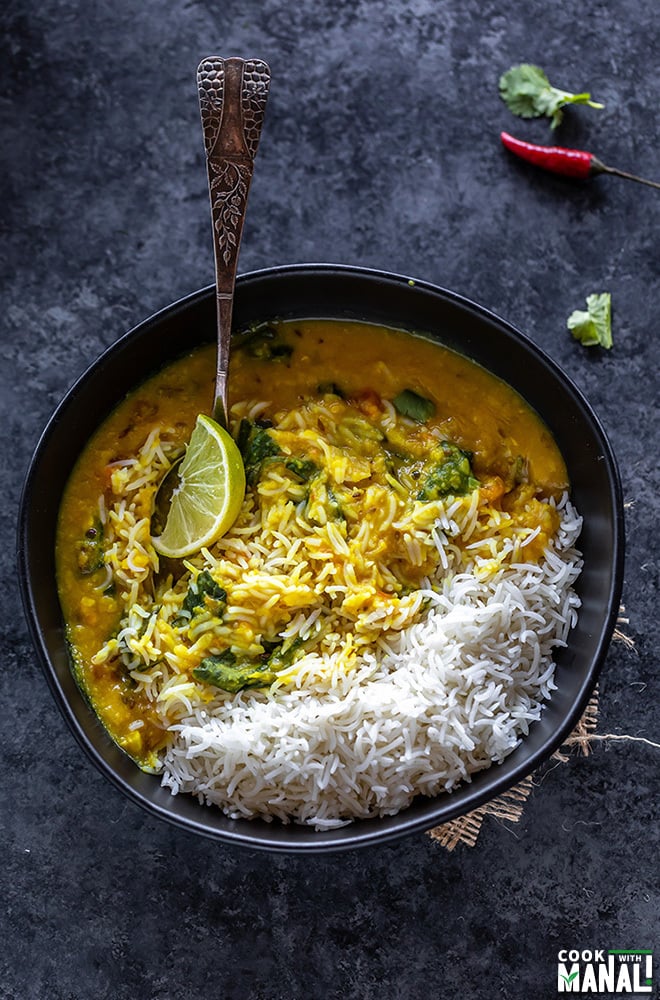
[{"left": 427, "top": 606, "right": 659, "bottom": 851}]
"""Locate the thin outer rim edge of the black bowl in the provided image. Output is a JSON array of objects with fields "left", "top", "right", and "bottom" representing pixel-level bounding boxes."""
[{"left": 17, "top": 263, "right": 625, "bottom": 854}]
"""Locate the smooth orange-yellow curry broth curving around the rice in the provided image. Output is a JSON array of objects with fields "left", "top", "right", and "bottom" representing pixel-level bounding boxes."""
[{"left": 56, "top": 320, "right": 568, "bottom": 765}]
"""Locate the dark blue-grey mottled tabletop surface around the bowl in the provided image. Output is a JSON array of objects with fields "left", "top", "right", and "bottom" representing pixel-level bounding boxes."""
[{"left": 0, "top": 0, "right": 660, "bottom": 1000}]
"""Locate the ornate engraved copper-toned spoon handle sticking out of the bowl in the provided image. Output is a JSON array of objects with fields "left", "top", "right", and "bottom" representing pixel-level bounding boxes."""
[{"left": 197, "top": 56, "right": 270, "bottom": 427}]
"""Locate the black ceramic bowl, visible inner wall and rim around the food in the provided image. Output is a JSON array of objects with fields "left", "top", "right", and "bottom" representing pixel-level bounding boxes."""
[{"left": 19, "top": 265, "right": 623, "bottom": 852}]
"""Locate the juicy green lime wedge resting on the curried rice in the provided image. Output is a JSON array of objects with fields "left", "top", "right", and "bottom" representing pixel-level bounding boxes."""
[{"left": 152, "top": 414, "right": 245, "bottom": 559}]
